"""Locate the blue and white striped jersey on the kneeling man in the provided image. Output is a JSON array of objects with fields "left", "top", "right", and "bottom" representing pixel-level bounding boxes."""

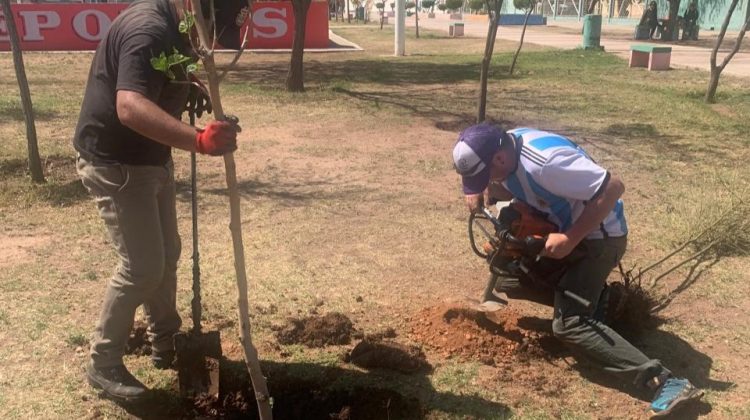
[{"left": 502, "top": 128, "right": 628, "bottom": 239}]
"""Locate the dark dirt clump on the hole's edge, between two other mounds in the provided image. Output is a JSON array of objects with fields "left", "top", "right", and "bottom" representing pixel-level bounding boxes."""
[{"left": 344, "top": 339, "right": 432, "bottom": 373}]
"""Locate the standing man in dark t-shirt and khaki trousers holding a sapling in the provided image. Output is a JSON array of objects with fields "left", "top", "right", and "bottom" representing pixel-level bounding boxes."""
[{"left": 73, "top": 0, "right": 249, "bottom": 402}]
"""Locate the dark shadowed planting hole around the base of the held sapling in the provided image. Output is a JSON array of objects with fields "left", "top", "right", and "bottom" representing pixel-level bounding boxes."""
[{"left": 111, "top": 359, "right": 511, "bottom": 420}]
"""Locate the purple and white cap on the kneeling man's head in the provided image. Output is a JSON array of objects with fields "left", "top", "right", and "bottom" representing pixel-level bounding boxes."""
[{"left": 453, "top": 123, "right": 508, "bottom": 194}]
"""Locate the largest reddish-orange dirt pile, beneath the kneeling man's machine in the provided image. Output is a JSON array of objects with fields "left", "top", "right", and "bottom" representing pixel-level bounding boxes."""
[{"left": 409, "top": 305, "right": 560, "bottom": 366}]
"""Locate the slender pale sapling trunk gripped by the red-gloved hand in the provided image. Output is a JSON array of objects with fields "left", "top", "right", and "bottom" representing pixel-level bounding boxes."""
[{"left": 188, "top": 0, "right": 273, "bottom": 420}]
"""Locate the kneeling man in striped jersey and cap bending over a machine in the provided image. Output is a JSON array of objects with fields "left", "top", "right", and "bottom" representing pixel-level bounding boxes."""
[{"left": 453, "top": 124, "right": 703, "bottom": 416}]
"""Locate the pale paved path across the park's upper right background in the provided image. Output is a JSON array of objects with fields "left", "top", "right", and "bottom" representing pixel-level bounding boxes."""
[{"left": 406, "top": 13, "right": 750, "bottom": 78}]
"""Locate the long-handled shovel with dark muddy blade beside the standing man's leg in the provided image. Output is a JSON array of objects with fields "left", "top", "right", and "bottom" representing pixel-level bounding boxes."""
[{"left": 174, "top": 112, "right": 221, "bottom": 398}]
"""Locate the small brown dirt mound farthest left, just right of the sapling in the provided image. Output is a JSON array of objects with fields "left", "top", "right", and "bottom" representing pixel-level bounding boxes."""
[{"left": 276, "top": 312, "right": 355, "bottom": 347}]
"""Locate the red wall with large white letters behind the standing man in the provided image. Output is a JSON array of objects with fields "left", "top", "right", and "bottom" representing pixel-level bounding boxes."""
[{"left": 0, "top": 1, "right": 328, "bottom": 51}]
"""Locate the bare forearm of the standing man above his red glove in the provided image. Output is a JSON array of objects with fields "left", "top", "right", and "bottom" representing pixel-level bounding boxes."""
[{"left": 117, "top": 90, "right": 196, "bottom": 151}]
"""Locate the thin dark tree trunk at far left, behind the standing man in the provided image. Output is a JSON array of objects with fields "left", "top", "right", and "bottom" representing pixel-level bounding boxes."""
[{"left": 0, "top": 0, "right": 45, "bottom": 184}]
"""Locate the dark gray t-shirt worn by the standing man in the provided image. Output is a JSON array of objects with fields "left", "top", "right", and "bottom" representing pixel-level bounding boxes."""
[{"left": 73, "top": 0, "right": 189, "bottom": 165}]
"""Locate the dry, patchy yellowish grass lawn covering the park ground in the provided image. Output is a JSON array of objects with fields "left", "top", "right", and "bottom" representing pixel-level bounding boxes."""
[{"left": 0, "top": 25, "right": 750, "bottom": 418}]
